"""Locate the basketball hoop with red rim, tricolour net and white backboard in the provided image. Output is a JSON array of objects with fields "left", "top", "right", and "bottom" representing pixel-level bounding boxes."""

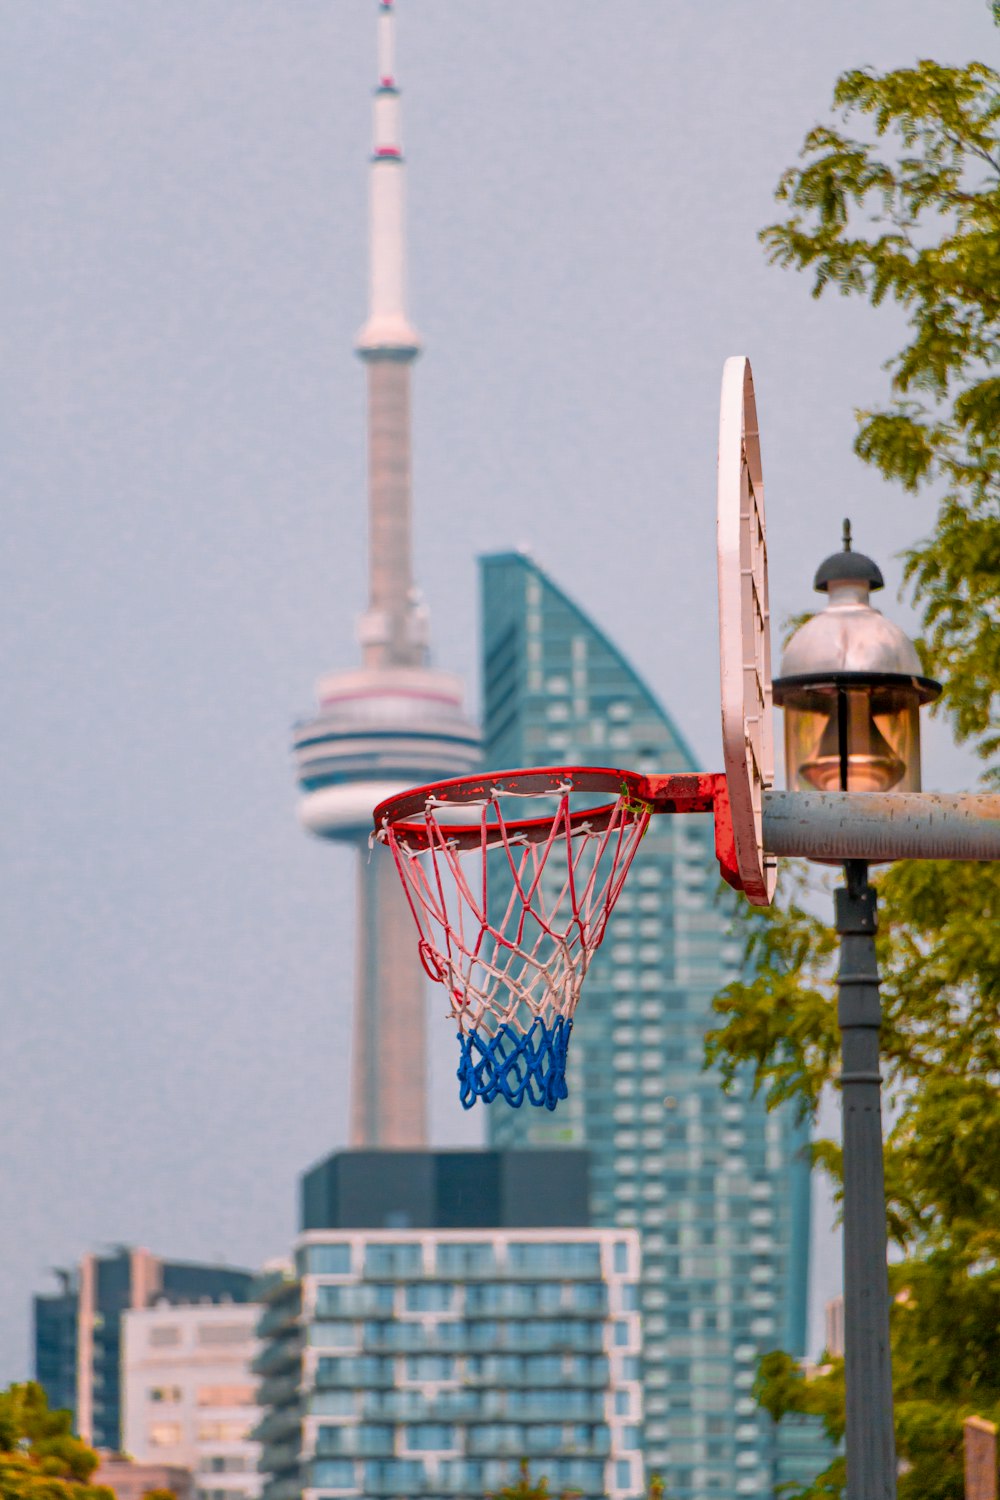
[{"left": 373, "top": 357, "right": 777, "bottom": 1110}]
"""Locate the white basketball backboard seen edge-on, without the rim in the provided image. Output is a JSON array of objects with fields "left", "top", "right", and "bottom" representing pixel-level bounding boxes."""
[{"left": 718, "top": 356, "right": 777, "bottom": 906}]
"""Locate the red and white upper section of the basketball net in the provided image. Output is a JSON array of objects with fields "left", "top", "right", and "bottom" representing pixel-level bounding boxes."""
[{"left": 381, "top": 788, "right": 649, "bottom": 1037}]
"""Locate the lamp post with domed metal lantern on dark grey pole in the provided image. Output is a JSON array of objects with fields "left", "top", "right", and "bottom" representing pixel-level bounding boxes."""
[{"left": 774, "top": 521, "right": 940, "bottom": 1500}]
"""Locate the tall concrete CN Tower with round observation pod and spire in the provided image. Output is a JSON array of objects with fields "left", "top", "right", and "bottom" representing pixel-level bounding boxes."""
[{"left": 294, "top": 0, "right": 480, "bottom": 1148}]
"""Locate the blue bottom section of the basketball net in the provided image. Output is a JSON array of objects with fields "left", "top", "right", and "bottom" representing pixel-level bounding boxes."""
[{"left": 457, "top": 1016, "right": 573, "bottom": 1110}]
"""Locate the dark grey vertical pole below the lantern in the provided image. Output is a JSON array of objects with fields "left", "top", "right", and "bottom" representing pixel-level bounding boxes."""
[{"left": 835, "top": 860, "right": 897, "bottom": 1500}]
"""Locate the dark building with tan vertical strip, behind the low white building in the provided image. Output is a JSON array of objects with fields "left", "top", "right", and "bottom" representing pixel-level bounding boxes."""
[{"left": 34, "top": 1245, "right": 253, "bottom": 1452}]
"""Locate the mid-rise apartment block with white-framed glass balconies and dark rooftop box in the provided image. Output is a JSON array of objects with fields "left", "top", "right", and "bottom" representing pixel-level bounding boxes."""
[{"left": 256, "top": 1151, "right": 643, "bottom": 1500}]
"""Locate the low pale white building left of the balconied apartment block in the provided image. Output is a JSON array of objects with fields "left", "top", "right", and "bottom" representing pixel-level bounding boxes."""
[{"left": 121, "top": 1302, "right": 261, "bottom": 1500}]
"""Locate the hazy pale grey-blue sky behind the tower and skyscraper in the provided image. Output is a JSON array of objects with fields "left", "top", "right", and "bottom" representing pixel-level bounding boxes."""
[{"left": 0, "top": 0, "right": 997, "bottom": 1382}]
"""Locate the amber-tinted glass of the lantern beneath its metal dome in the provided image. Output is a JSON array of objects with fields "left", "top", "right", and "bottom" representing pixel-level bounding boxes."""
[{"left": 783, "top": 683, "right": 921, "bottom": 792}]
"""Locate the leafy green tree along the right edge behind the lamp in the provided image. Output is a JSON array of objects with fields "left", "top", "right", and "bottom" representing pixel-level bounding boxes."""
[{"left": 708, "top": 23, "right": 1000, "bottom": 1500}]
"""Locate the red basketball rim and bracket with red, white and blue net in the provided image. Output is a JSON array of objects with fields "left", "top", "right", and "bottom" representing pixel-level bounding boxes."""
[{"left": 373, "top": 767, "right": 736, "bottom": 1110}]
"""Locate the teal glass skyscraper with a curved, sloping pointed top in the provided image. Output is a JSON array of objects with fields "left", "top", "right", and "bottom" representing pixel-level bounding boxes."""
[{"left": 481, "top": 554, "right": 810, "bottom": 1500}]
